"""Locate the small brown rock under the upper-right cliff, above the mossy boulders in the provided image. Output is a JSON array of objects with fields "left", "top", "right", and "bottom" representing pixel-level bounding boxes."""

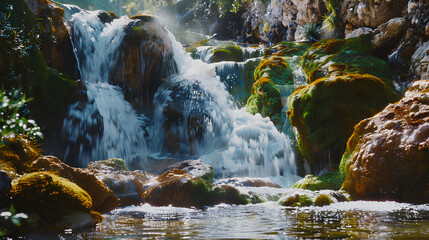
[{"left": 371, "top": 18, "right": 407, "bottom": 56}]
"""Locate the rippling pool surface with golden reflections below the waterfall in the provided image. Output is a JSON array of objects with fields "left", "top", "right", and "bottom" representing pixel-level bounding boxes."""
[{"left": 61, "top": 202, "right": 429, "bottom": 239}]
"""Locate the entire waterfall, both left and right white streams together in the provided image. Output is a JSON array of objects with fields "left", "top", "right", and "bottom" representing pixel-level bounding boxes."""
[{"left": 63, "top": 6, "right": 296, "bottom": 186}]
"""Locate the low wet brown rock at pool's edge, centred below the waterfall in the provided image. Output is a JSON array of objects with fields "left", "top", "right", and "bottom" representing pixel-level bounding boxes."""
[{"left": 144, "top": 169, "right": 249, "bottom": 208}]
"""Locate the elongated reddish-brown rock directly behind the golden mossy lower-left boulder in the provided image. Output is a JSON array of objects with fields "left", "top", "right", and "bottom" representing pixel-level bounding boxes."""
[{"left": 32, "top": 156, "right": 119, "bottom": 213}]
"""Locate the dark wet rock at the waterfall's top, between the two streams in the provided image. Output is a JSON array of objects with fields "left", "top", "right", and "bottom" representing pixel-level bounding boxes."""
[{"left": 111, "top": 16, "right": 176, "bottom": 106}]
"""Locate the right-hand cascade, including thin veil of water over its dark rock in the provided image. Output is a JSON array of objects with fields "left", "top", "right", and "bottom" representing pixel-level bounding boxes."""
[{"left": 150, "top": 31, "right": 296, "bottom": 186}]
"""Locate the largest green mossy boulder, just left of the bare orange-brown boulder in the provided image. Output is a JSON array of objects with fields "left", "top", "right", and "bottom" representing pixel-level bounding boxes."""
[{"left": 287, "top": 74, "right": 398, "bottom": 171}]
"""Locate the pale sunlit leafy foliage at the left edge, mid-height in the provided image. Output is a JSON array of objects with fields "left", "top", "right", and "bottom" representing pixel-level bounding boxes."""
[{"left": 0, "top": 90, "right": 43, "bottom": 139}]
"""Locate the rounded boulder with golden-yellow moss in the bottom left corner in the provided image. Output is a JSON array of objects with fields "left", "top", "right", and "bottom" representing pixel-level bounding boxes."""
[{"left": 10, "top": 172, "right": 102, "bottom": 231}]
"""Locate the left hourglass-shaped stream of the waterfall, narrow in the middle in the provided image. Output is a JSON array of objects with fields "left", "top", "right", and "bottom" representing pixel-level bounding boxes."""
[{"left": 63, "top": 11, "right": 147, "bottom": 169}]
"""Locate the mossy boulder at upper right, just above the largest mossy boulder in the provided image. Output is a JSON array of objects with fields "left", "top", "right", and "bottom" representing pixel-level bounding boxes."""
[{"left": 300, "top": 35, "right": 390, "bottom": 83}]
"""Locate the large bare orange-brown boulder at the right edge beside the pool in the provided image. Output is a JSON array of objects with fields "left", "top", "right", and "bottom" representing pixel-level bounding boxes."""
[{"left": 342, "top": 80, "right": 429, "bottom": 203}]
